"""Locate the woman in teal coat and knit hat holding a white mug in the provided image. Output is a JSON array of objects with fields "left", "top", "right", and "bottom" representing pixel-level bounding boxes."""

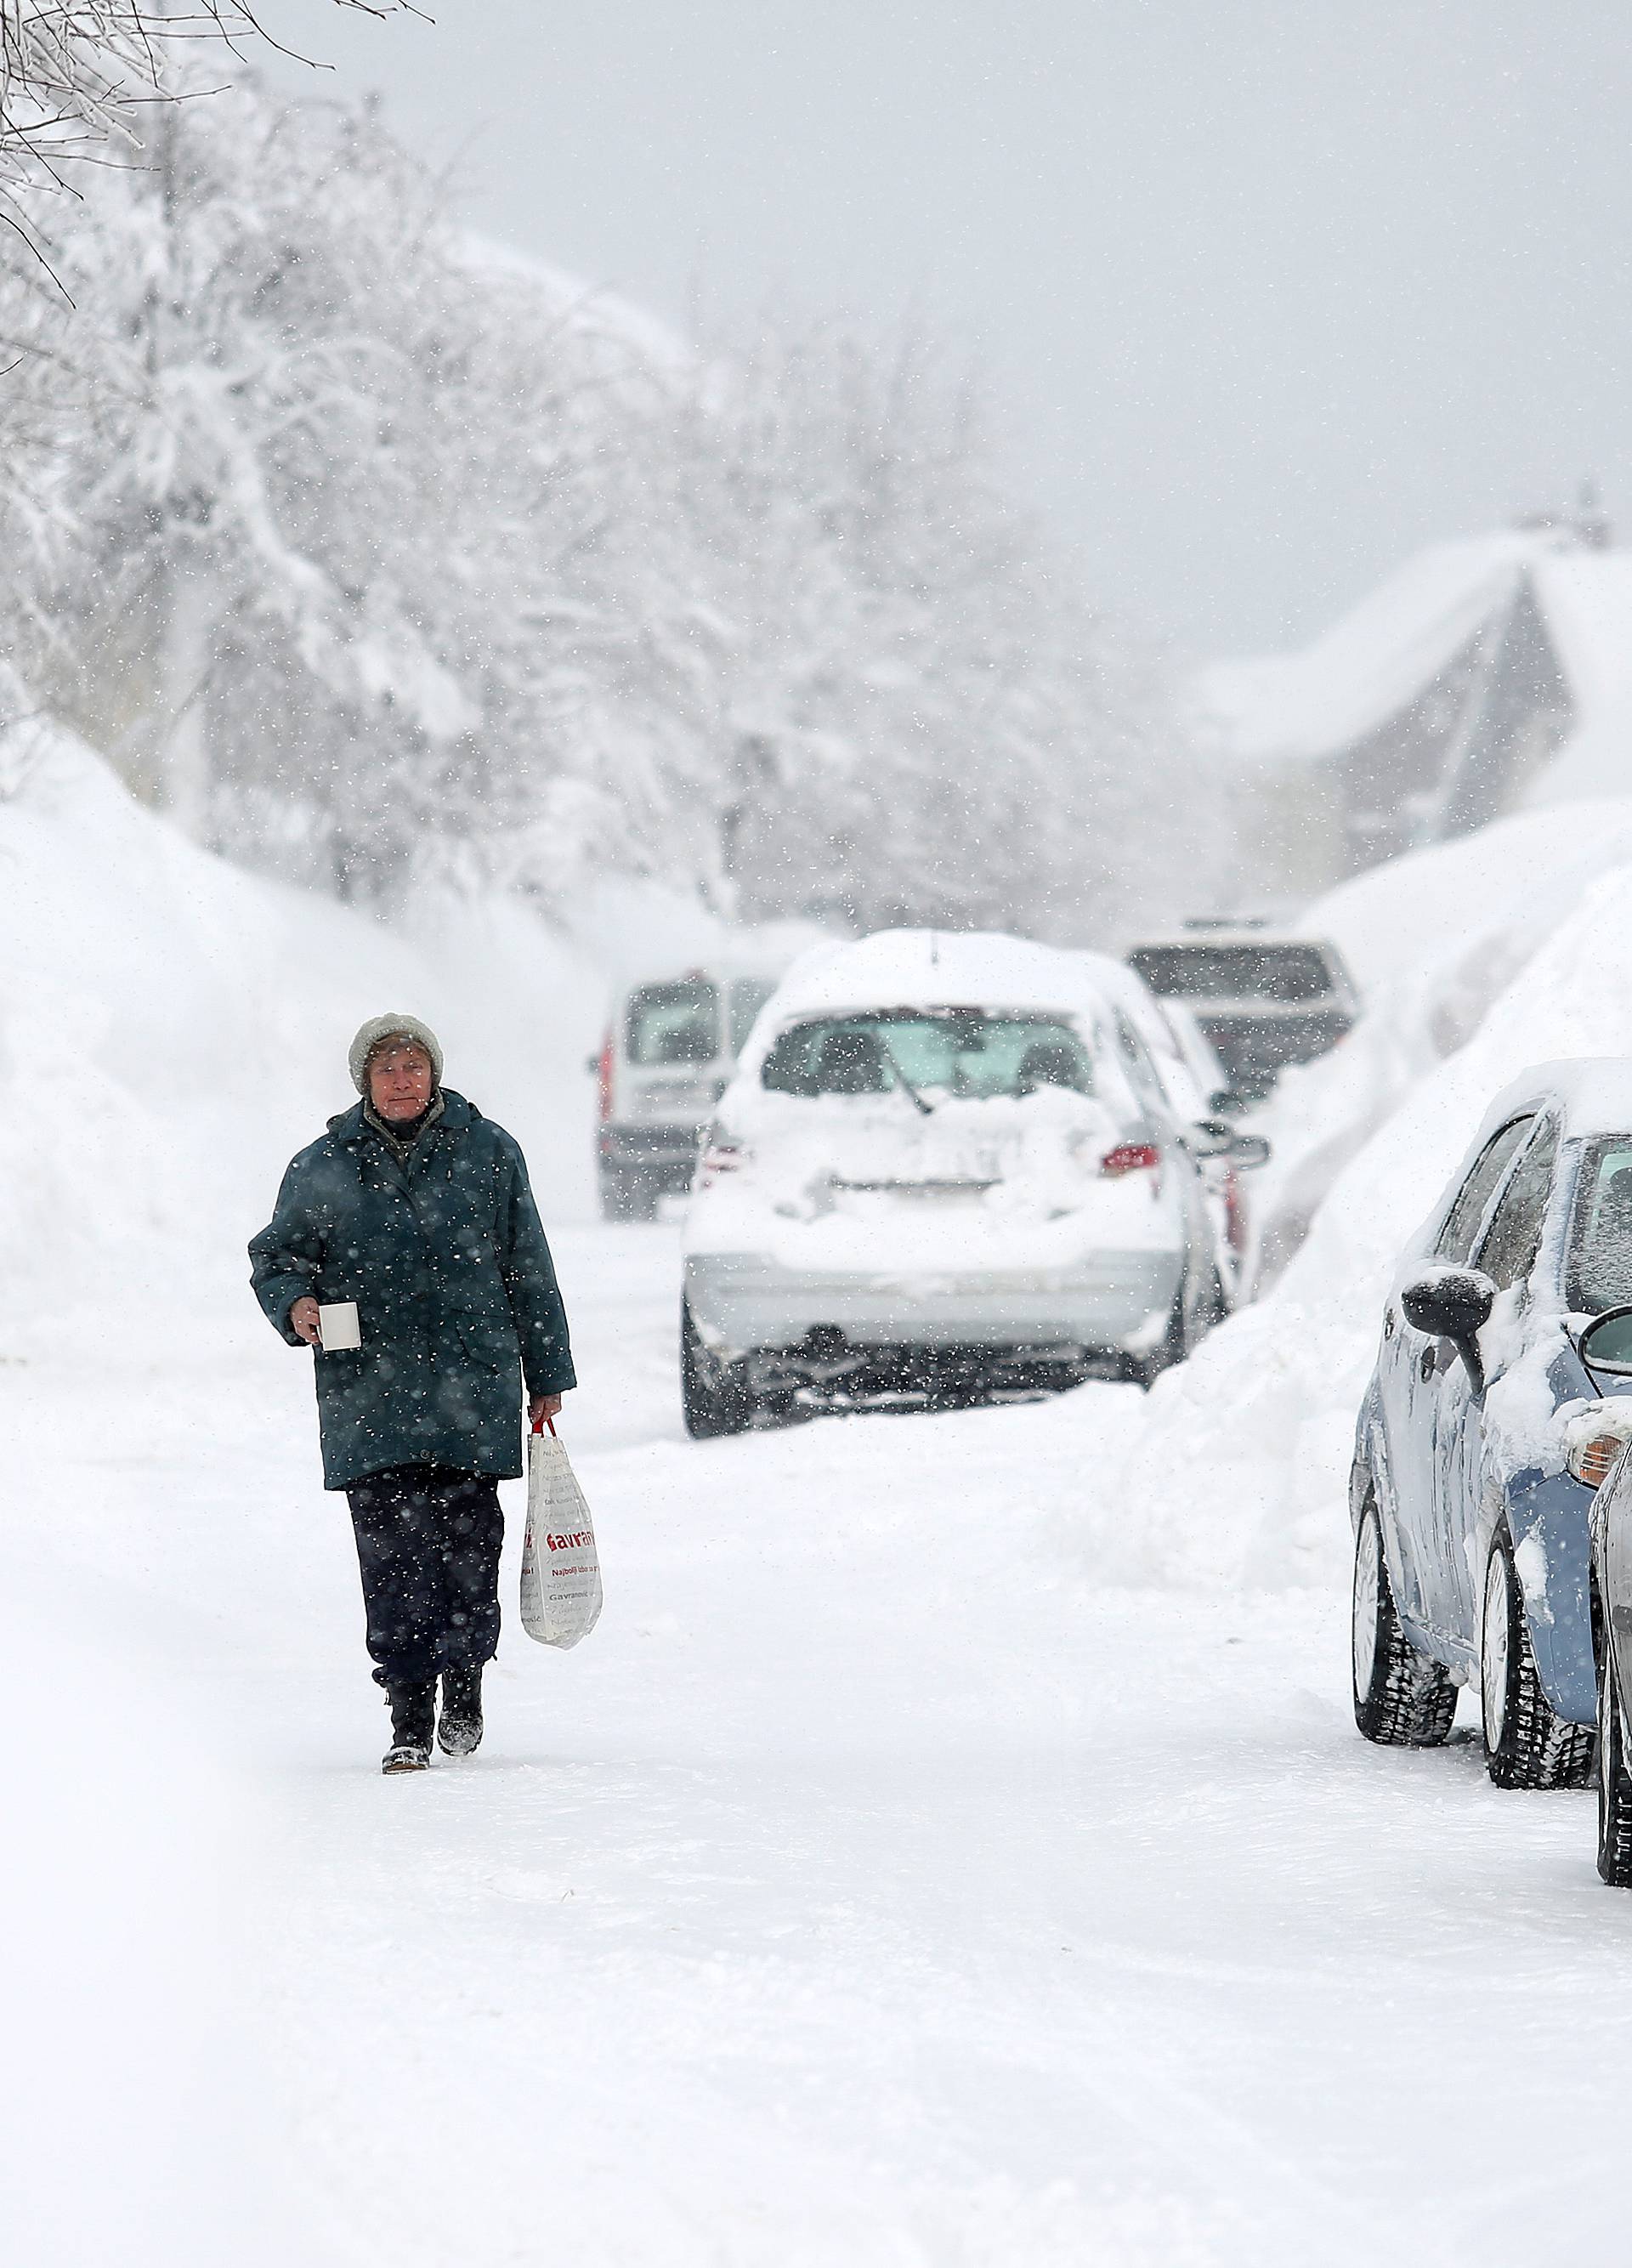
[{"left": 249, "top": 1016, "right": 575, "bottom": 1772}]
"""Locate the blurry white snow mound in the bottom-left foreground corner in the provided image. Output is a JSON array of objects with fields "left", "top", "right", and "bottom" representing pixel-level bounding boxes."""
[{"left": 0, "top": 1578, "right": 337, "bottom": 2268}]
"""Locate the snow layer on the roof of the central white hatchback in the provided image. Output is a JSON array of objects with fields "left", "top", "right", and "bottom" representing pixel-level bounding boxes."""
[{"left": 773, "top": 930, "right": 1138, "bottom": 1025}]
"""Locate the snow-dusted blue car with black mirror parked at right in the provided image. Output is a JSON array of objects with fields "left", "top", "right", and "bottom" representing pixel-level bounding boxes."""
[{"left": 1349, "top": 1059, "right": 1632, "bottom": 1787}]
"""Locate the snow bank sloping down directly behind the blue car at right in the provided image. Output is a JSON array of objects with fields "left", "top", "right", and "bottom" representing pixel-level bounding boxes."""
[{"left": 1065, "top": 865, "right": 1632, "bottom": 1588}]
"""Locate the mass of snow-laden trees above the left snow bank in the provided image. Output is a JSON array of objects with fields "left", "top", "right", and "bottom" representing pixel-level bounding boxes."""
[{"left": 0, "top": 68, "right": 1204, "bottom": 939}]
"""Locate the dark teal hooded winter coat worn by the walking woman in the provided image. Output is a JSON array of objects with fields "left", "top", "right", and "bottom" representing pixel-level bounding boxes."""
[{"left": 249, "top": 1091, "right": 575, "bottom": 1488}]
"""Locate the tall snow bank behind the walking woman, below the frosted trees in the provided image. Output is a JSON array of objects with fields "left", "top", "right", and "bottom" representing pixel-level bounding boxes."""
[{"left": 0, "top": 726, "right": 752, "bottom": 1356}]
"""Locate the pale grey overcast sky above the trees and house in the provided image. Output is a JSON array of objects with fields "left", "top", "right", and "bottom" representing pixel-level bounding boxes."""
[{"left": 261, "top": 0, "right": 1632, "bottom": 653}]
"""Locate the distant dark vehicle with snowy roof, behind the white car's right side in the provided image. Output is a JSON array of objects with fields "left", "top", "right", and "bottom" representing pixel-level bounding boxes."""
[{"left": 1129, "top": 923, "right": 1360, "bottom": 1100}]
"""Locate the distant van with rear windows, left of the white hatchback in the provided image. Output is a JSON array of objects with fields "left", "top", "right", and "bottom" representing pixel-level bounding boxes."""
[{"left": 589, "top": 948, "right": 791, "bottom": 1220}]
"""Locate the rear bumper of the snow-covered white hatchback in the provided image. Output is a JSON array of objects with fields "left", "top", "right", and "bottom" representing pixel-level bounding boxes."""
[{"left": 684, "top": 1250, "right": 1183, "bottom": 1363}]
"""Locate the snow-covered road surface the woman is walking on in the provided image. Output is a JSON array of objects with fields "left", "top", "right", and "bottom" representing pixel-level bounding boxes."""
[{"left": 0, "top": 1227, "right": 1632, "bottom": 2268}]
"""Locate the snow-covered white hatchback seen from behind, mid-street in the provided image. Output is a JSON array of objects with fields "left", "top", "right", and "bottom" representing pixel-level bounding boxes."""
[{"left": 683, "top": 930, "right": 1260, "bottom": 1436}]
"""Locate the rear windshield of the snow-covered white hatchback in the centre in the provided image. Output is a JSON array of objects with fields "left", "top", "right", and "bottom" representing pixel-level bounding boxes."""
[{"left": 762, "top": 1009, "right": 1092, "bottom": 1100}]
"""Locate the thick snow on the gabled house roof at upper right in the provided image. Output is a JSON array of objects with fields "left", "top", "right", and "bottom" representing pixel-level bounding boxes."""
[{"left": 1194, "top": 529, "right": 1632, "bottom": 802}]
